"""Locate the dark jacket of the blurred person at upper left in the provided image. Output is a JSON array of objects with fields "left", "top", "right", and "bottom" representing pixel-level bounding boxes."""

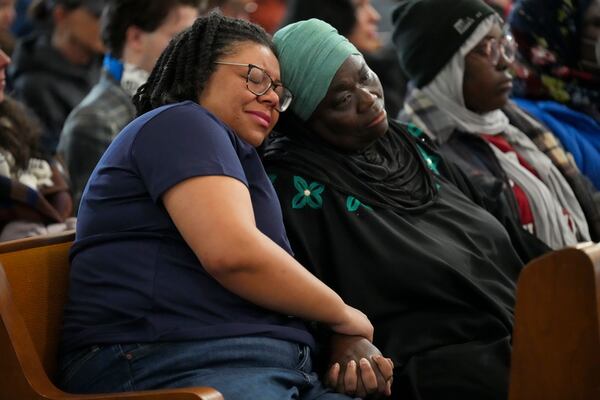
[{"left": 8, "top": 31, "right": 100, "bottom": 155}]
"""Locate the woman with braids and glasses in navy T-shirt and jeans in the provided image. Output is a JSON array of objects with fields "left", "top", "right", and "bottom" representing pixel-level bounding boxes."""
[{"left": 59, "top": 13, "right": 392, "bottom": 400}]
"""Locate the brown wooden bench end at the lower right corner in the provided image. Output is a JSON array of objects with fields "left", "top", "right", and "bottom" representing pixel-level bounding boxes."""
[{"left": 509, "top": 243, "right": 600, "bottom": 400}]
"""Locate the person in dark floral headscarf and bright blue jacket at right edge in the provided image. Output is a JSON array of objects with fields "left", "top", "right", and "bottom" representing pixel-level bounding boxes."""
[{"left": 509, "top": 0, "right": 600, "bottom": 190}]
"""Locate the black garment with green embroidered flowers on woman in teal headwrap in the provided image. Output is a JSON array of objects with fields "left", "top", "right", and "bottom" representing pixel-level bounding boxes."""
[{"left": 264, "top": 119, "right": 522, "bottom": 400}]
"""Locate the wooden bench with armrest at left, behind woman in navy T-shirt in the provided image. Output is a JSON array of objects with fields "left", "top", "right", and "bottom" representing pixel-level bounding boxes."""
[{"left": 0, "top": 232, "right": 223, "bottom": 400}]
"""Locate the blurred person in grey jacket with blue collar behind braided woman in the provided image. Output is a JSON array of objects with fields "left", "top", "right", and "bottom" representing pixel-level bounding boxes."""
[{"left": 58, "top": 0, "right": 200, "bottom": 211}]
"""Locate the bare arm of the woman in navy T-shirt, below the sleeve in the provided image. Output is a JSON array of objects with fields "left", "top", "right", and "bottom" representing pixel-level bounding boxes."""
[{"left": 164, "top": 176, "right": 373, "bottom": 340}]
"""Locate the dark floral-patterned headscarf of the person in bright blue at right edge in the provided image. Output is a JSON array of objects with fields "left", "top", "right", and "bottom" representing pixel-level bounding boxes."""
[{"left": 509, "top": 0, "right": 600, "bottom": 118}]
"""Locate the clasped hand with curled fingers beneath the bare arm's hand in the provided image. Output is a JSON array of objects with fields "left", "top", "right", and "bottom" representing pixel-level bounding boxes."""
[{"left": 325, "top": 335, "right": 394, "bottom": 397}]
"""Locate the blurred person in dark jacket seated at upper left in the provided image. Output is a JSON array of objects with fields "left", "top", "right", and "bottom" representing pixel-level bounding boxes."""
[{"left": 9, "top": 0, "right": 104, "bottom": 156}]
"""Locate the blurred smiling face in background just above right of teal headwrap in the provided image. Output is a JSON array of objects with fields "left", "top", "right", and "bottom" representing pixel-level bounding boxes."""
[{"left": 348, "top": 0, "right": 381, "bottom": 53}]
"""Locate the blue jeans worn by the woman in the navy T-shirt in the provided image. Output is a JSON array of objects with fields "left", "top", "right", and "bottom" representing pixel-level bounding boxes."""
[{"left": 59, "top": 337, "right": 349, "bottom": 400}]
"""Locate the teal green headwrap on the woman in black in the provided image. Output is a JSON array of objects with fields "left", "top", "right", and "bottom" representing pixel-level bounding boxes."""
[{"left": 273, "top": 18, "right": 360, "bottom": 121}]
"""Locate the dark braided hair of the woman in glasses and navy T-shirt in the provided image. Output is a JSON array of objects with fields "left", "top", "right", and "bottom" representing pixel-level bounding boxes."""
[{"left": 133, "top": 11, "right": 276, "bottom": 116}]
